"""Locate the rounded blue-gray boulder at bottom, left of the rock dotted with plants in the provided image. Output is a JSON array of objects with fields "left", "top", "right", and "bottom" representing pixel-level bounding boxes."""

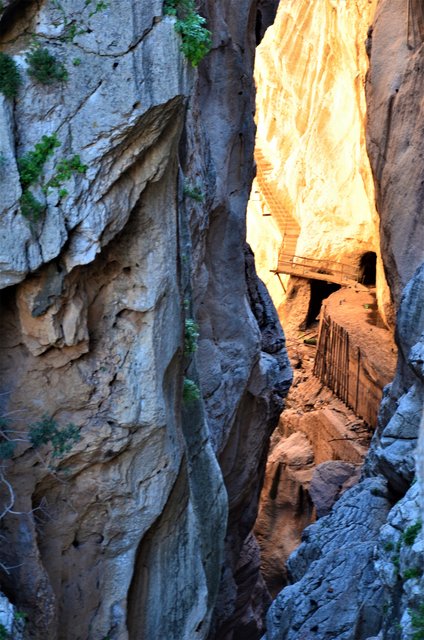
[{"left": 264, "top": 479, "right": 390, "bottom": 640}]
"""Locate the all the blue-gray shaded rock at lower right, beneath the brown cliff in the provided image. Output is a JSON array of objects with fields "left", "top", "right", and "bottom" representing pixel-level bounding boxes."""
[{"left": 264, "top": 267, "right": 424, "bottom": 640}]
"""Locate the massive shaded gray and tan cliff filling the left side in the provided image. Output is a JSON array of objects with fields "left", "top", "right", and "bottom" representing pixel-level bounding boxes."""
[{"left": 0, "top": 0, "right": 290, "bottom": 640}]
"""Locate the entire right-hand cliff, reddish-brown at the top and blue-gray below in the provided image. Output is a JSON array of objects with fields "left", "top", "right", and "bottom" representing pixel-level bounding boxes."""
[{"left": 265, "top": 0, "right": 424, "bottom": 640}]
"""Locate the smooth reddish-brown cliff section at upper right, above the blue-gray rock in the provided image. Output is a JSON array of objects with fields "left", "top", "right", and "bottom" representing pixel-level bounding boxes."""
[{"left": 367, "top": 0, "right": 424, "bottom": 305}]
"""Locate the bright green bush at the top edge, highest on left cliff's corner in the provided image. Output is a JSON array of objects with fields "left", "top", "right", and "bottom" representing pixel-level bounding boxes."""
[{"left": 164, "top": 0, "right": 212, "bottom": 67}]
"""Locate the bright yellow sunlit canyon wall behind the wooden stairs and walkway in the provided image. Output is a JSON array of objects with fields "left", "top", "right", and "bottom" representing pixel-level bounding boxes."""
[{"left": 248, "top": 0, "right": 390, "bottom": 324}]
